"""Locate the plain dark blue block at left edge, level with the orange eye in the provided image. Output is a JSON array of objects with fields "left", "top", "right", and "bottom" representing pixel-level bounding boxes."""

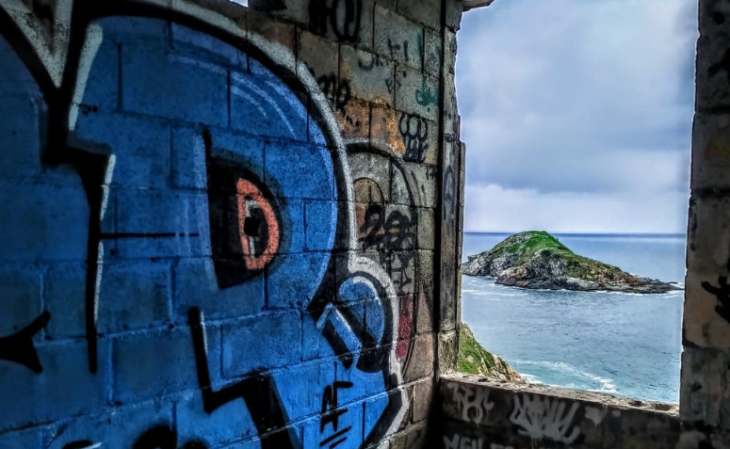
[{"left": 0, "top": 184, "right": 89, "bottom": 261}]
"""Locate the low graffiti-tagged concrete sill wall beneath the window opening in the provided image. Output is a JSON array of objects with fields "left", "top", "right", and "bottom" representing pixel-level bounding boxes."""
[{"left": 438, "top": 374, "right": 680, "bottom": 449}]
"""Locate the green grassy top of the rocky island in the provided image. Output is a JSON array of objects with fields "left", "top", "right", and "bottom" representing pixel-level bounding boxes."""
[{"left": 489, "top": 231, "right": 621, "bottom": 279}]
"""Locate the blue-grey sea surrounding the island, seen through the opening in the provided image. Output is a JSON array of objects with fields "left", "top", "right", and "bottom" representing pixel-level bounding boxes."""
[{"left": 462, "top": 233, "right": 686, "bottom": 403}]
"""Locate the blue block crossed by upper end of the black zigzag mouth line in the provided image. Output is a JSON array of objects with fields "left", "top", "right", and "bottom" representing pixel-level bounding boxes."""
[{"left": 113, "top": 326, "right": 210, "bottom": 403}]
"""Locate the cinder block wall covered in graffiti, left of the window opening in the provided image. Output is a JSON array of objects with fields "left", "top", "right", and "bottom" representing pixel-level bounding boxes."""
[{"left": 0, "top": 0, "right": 463, "bottom": 449}]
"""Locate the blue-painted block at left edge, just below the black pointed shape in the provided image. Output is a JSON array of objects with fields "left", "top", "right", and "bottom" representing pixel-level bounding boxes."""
[{"left": 0, "top": 340, "right": 111, "bottom": 432}]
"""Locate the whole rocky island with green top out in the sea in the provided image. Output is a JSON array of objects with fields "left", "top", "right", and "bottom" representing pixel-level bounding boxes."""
[{"left": 461, "top": 231, "right": 681, "bottom": 293}]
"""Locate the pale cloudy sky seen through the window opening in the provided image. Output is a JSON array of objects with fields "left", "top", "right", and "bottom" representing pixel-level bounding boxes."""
[{"left": 456, "top": 0, "right": 698, "bottom": 233}]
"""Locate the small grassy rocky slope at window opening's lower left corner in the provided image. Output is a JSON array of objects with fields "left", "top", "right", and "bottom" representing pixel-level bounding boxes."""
[{"left": 458, "top": 323, "right": 526, "bottom": 383}]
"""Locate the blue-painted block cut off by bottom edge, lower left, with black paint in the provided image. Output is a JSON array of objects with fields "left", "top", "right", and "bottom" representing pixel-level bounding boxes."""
[{"left": 43, "top": 401, "right": 174, "bottom": 449}]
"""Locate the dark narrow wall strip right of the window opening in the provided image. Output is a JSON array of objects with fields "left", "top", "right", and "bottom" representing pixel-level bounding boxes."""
[{"left": 680, "top": 0, "right": 730, "bottom": 448}]
